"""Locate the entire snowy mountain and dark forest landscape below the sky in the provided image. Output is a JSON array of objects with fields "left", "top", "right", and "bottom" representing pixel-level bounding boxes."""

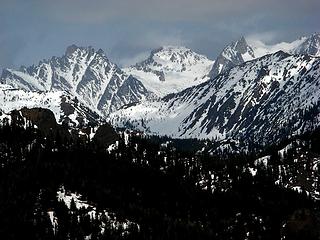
[{"left": 0, "top": 33, "right": 320, "bottom": 240}]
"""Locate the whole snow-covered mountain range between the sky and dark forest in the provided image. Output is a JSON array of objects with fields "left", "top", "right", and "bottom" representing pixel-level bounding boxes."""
[{"left": 2, "top": 34, "right": 320, "bottom": 145}]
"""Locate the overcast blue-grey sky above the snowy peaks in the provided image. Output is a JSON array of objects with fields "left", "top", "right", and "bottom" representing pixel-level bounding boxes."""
[{"left": 0, "top": 0, "right": 320, "bottom": 69}]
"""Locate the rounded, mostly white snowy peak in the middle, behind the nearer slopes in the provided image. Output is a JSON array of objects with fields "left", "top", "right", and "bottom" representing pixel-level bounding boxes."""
[{"left": 124, "top": 46, "right": 213, "bottom": 97}]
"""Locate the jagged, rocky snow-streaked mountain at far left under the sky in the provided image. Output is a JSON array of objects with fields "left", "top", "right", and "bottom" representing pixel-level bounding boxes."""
[{"left": 1, "top": 45, "right": 152, "bottom": 115}]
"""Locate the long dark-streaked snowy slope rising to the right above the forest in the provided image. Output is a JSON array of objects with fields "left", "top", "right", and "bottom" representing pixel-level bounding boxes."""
[{"left": 111, "top": 51, "right": 320, "bottom": 143}]
